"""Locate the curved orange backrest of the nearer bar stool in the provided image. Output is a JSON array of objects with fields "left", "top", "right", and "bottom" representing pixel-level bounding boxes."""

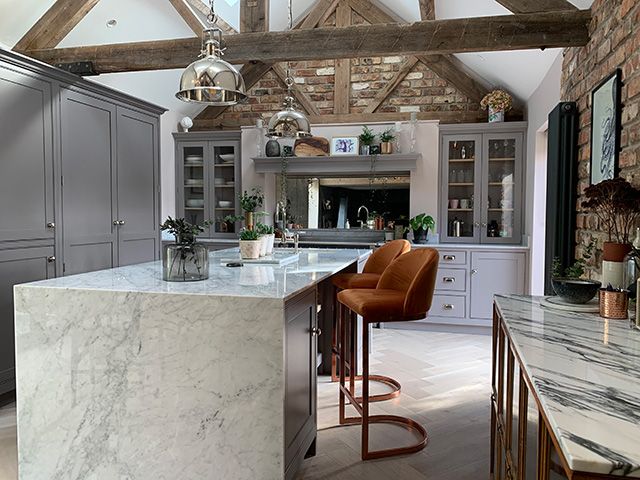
[{"left": 377, "top": 248, "right": 439, "bottom": 319}]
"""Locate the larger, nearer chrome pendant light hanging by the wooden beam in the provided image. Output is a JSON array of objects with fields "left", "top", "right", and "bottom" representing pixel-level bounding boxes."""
[{"left": 176, "top": 0, "right": 247, "bottom": 107}]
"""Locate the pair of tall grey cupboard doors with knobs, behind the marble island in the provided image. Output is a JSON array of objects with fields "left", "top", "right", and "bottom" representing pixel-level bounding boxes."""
[{"left": 61, "top": 89, "right": 160, "bottom": 275}]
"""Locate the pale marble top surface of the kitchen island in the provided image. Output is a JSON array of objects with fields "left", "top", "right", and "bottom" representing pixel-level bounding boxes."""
[{"left": 21, "top": 248, "right": 370, "bottom": 299}]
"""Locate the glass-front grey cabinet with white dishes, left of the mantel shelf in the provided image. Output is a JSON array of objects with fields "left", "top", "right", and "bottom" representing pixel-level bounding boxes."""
[{"left": 174, "top": 132, "right": 241, "bottom": 238}]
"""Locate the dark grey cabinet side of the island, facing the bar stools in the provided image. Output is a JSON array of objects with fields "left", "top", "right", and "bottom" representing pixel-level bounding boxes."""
[{"left": 284, "top": 288, "right": 317, "bottom": 480}]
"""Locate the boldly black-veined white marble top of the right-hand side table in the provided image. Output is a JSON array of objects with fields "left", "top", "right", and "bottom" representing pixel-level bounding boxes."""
[{"left": 496, "top": 295, "right": 640, "bottom": 478}]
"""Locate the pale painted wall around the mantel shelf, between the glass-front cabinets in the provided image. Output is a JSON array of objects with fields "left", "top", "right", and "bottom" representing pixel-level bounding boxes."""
[{"left": 242, "top": 121, "right": 439, "bottom": 230}]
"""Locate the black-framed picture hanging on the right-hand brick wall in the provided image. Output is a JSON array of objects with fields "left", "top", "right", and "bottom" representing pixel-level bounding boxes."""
[{"left": 591, "top": 69, "right": 622, "bottom": 184}]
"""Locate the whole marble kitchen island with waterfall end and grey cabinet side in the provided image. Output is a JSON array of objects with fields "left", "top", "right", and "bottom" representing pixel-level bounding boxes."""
[{"left": 14, "top": 249, "right": 370, "bottom": 480}]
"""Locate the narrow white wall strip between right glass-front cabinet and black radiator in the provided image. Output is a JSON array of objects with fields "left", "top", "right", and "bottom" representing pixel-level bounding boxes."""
[{"left": 525, "top": 53, "right": 562, "bottom": 295}]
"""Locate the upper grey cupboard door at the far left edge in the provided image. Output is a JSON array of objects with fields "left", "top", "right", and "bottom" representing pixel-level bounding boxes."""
[{"left": 0, "top": 63, "right": 55, "bottom": 242}]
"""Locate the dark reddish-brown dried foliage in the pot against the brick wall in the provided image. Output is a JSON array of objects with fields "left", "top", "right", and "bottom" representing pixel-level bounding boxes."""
[{"left": 582, "top": 178, "right": 640, "bottom": 244}]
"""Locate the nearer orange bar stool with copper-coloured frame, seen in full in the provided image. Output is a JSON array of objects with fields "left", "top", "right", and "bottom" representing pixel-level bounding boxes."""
[{"left": 338, "top": 248, "right": 438, "bottom": 460}]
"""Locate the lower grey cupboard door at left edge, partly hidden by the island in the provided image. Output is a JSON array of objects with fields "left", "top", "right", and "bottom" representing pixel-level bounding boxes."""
[{"left": 0, "top": 246, "right": 56, "bottom": 395}]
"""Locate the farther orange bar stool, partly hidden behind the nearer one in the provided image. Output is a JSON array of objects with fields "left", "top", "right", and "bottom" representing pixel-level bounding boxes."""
[{"left": 331, "top": 240, "right": 411, "bottom": 402}]
